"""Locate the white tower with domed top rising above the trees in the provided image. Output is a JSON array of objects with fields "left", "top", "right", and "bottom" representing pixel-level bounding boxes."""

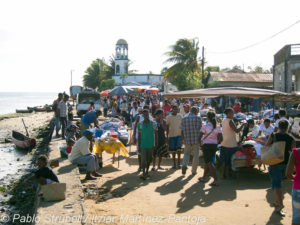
[{"left": 115, "top": 39, "right": 129, "bottom": 76}]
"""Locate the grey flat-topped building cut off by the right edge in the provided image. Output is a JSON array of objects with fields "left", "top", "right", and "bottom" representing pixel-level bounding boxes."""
[{"left": 273, "top": 44, "right": 300, "bottom": 93}]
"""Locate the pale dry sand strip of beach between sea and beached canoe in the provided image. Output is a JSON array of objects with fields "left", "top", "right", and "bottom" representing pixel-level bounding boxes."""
[{"left": 0, "top": 112, "right": 53, "bottom": 139}]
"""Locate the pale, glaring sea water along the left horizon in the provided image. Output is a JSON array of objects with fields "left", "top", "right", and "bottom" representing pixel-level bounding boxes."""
[{"left": 0, "top": 92, "right": 58, "bottom": 115}]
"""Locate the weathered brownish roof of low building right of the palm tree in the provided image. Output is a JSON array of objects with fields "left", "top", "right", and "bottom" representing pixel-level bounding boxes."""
[{"left": 211, "top": 72, "right": 273, "bottom": 83}]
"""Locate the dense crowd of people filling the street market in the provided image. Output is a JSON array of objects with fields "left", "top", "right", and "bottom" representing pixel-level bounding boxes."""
[{"left": 25, "top": 94, "right": 300, "bottom": 224}]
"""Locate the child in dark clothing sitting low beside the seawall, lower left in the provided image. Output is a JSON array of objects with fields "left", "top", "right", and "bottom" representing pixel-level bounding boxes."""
[{"left": 24, "top": 155, "right": 59, "bottom": 185}]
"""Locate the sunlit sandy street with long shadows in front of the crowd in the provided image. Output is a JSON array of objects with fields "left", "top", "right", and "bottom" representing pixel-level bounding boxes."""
[{"left": 81, "top": 147, "right": 291, "bottom": 225}]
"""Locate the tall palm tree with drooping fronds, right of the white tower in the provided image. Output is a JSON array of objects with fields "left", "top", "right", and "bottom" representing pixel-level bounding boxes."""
[{"left": 165, "top": 38, "right": 200, "bottom": 79}]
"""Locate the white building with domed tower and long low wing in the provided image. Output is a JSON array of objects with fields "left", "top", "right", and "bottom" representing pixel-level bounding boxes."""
[{"left": 113, "top": 39, "right": 164, "bottom": 86}]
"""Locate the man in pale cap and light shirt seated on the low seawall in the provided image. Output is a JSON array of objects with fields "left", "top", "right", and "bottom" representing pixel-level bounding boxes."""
[{"left": 69, "top": 130, "right": 102, "bottom": 180}]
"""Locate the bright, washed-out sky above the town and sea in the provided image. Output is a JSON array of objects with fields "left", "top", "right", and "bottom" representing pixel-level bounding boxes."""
[{"left": 0, "top": 0, "right": 300, "bottom": 92}]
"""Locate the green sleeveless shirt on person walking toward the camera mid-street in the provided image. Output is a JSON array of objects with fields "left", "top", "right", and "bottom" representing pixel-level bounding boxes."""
[{"left": 138, "top": 121, "right": 157, "bottom": 148}]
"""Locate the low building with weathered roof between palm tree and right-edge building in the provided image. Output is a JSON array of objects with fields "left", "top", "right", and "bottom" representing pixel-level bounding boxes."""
[{"left": 209, "top": 72, "right": 273, "bottom": 89}]
